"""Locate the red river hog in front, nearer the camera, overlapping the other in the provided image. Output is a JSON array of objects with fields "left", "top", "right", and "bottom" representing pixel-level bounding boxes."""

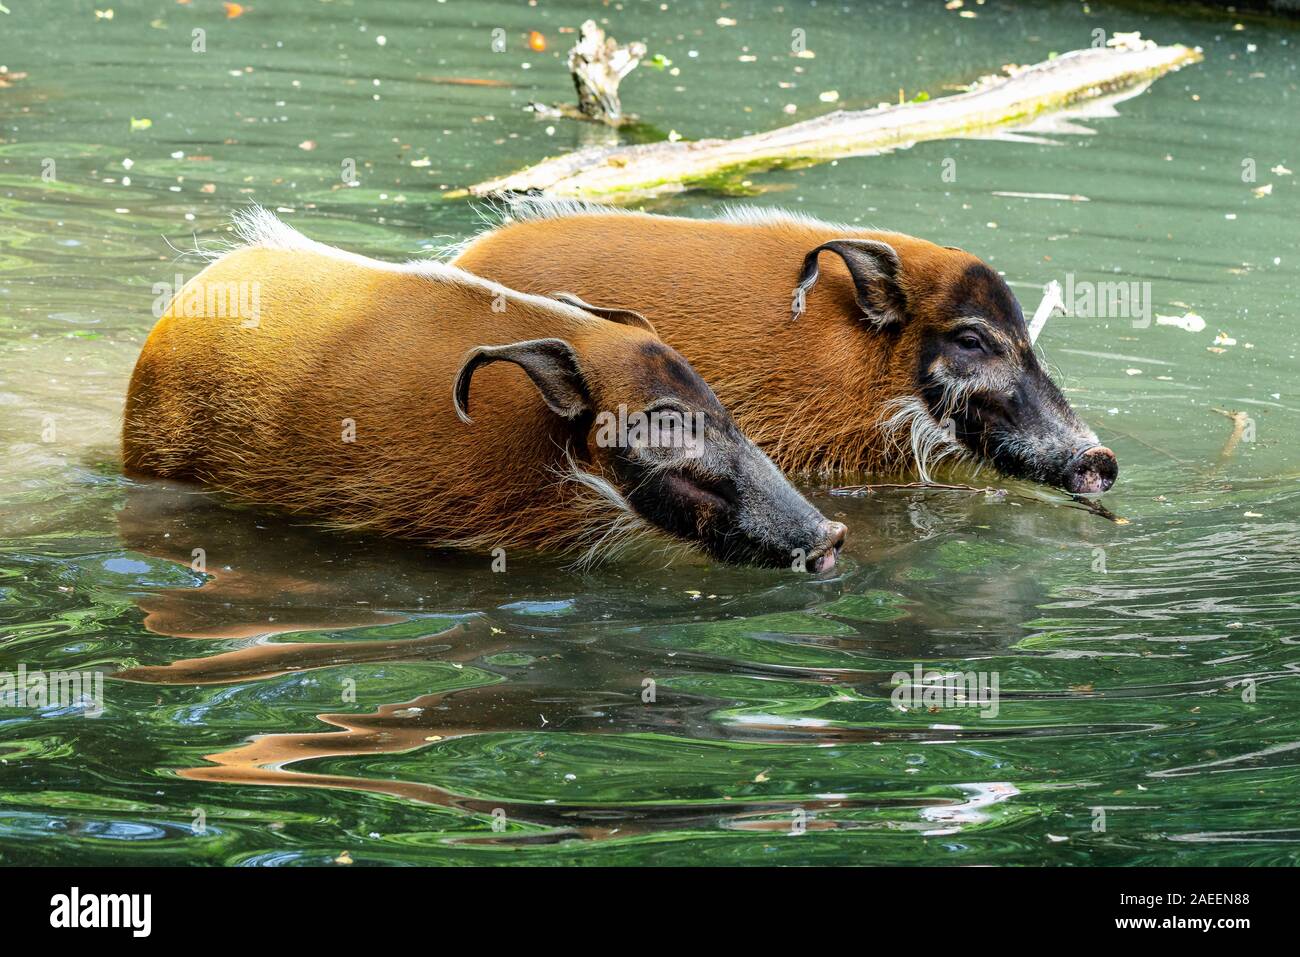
[{"left": 122, "top": 209, "right": 845, "bottom": 572}]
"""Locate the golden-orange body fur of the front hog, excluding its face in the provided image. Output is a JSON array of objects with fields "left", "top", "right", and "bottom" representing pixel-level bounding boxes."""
[{"left": 122, "top": 217, "right": 681, "bottom": 550}]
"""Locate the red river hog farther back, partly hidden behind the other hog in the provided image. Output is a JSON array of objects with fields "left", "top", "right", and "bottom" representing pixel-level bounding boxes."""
[{"left": 454, "top": 198, "right": 1118, "bottom": 493}]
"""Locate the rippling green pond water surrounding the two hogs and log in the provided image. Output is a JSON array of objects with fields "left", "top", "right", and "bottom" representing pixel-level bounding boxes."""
[{"left": 0, "top": 0, "right": 1300, "bottom": 865}]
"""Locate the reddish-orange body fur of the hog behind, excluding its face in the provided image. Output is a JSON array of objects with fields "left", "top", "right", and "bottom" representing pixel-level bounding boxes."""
[{"left": 454, "top": 208, "right": 979, "bottom": 472}]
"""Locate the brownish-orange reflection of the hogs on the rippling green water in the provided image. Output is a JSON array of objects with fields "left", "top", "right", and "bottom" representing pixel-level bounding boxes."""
[{"left": 116, "top": 482, "right": 1190, "bottom": 843}]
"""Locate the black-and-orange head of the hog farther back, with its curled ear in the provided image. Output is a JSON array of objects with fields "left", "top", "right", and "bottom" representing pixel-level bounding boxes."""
[{"left": 792, "top": 237, "right": 1118, "bottom": 493}]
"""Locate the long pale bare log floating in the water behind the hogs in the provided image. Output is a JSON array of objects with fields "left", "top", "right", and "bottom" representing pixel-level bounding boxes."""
[{"left": 465, "top": 35, "right": 1201, "bottom": 202}]
